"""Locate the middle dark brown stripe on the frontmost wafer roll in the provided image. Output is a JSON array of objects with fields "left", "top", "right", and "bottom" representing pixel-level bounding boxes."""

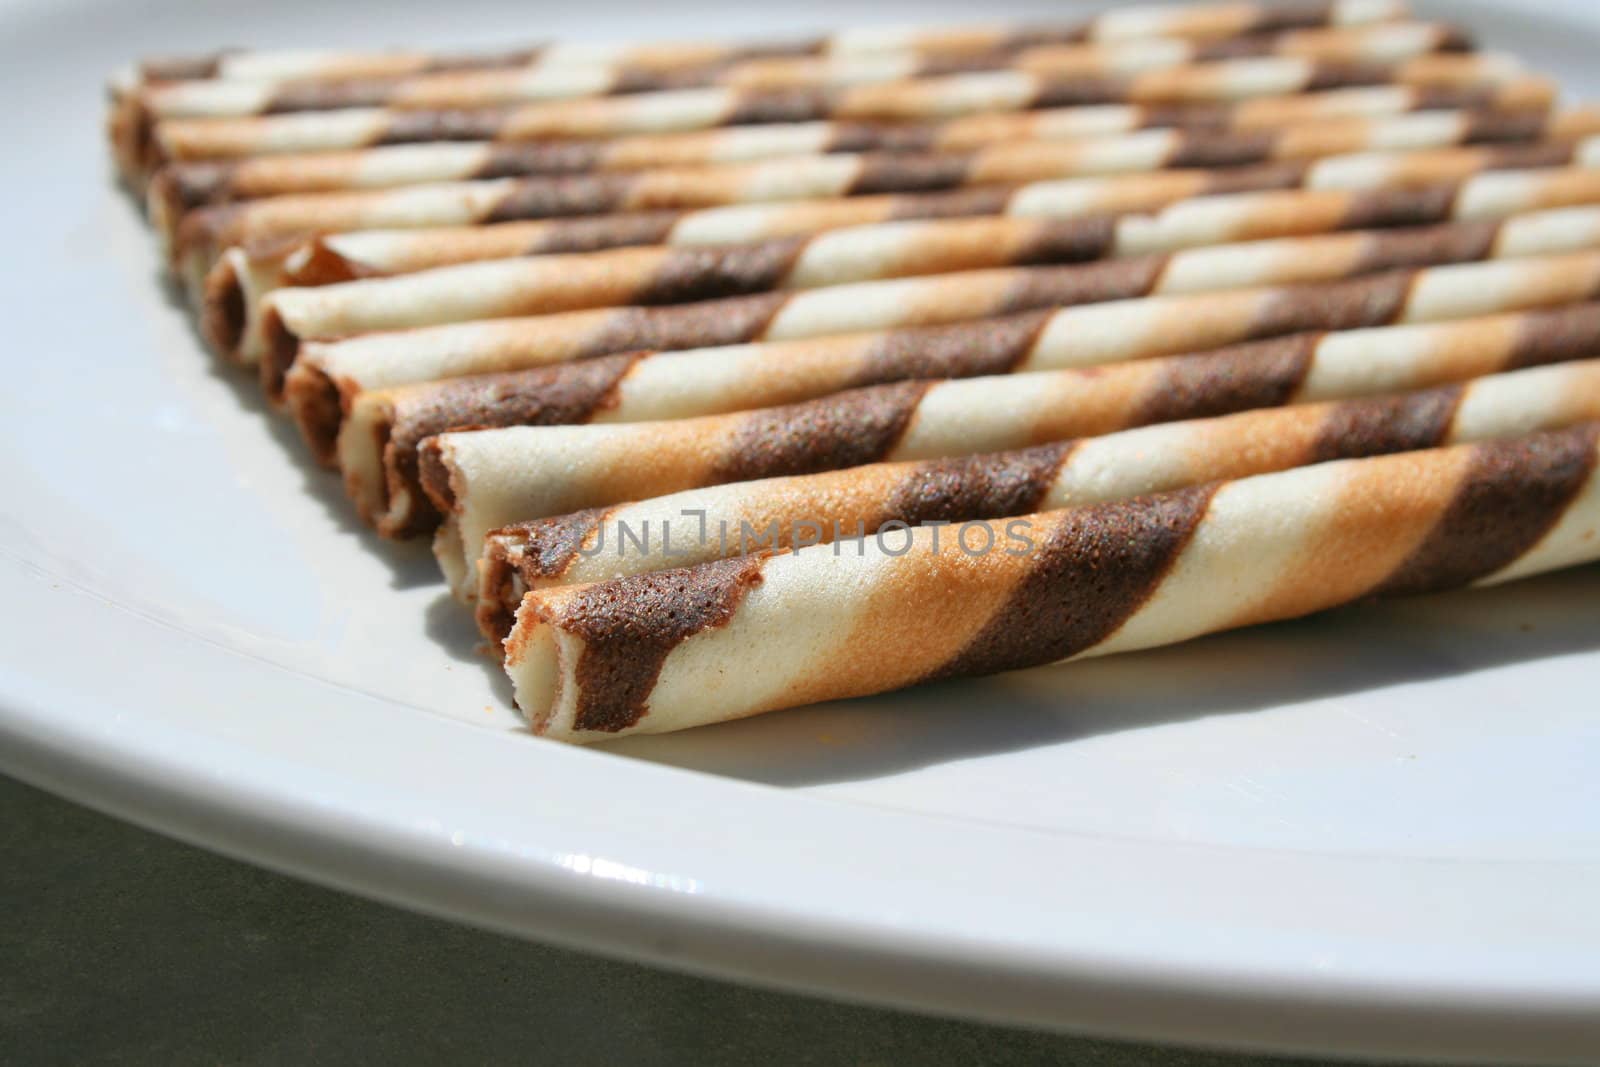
[{"left": 928, "top": 485, "right": 1216, "bottom": 678}]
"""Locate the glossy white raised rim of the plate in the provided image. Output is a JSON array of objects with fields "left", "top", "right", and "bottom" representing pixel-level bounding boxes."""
[{"left": 9, "top": 0, "right": 1600, "bottom": 1062}]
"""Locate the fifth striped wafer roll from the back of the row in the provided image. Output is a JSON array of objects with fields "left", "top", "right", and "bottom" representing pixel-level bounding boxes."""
[{"left": 163, "top": 131, "right": 1580, "bottom": 287}]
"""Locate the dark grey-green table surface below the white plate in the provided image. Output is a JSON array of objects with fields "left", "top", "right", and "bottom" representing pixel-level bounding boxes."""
[{"left": 0, "top": 777, "right": 1401, "bottom": 1067}]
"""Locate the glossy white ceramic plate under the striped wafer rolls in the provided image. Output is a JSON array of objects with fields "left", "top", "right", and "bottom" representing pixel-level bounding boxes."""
[{"left": 0, "top": 0, "right": 1600, "bottom": 1061}]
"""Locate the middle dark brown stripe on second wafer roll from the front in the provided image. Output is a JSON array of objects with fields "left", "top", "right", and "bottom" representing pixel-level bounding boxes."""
[{"left": 878, "top": 442, "right": 1075, "bottom": 525}]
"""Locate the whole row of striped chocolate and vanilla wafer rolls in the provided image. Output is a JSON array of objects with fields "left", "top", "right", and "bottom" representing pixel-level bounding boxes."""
[{"left": 110, "top": 0, "right": 1600, "bottom": 741}]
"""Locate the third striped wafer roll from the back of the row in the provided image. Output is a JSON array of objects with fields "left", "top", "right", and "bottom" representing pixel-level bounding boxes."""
[{"left": 136, "top": 53, "right": 1529, "bottom": 173}]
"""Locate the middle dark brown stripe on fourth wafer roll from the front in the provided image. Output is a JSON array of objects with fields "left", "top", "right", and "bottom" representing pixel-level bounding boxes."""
[{"left": 850, "top": 310, "right": 1051, "bottom": 387}]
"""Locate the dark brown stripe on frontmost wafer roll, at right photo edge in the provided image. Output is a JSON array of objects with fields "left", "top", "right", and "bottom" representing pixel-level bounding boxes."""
[{"left": 1373, "top": 422, "right": 1600, "bottom": 595}]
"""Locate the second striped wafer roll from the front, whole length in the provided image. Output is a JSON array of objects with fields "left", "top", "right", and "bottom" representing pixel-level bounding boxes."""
[{"left": 475, "top": 363, "right": 1600, "bottom": 641}]
